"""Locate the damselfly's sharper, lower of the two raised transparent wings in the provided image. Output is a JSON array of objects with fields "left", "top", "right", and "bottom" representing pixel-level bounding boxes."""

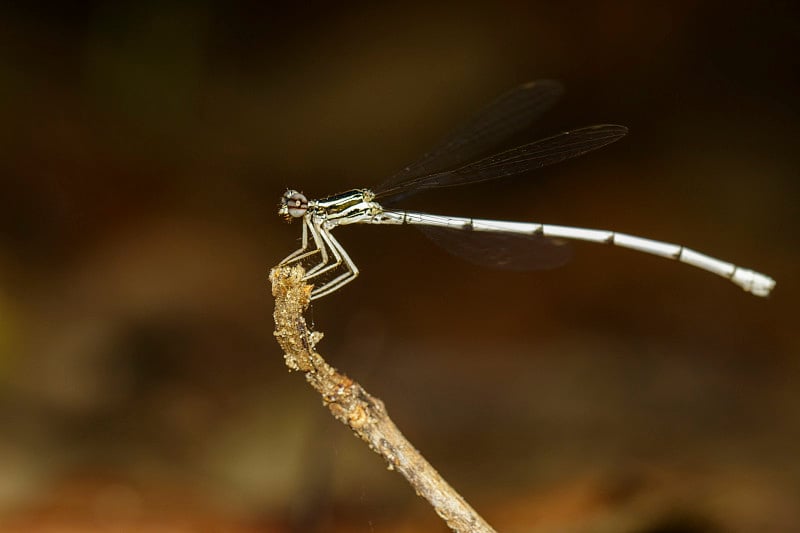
[{"left": 373, "top": 124, "right": 628, "bottom": 198}]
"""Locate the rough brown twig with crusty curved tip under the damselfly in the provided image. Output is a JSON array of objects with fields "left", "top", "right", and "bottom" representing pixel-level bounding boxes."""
[{"left": 270, "top": 266, "right": 495, "bottom": 533}]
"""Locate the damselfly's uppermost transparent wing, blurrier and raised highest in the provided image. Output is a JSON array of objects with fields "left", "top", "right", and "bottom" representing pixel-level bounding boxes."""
[{"left": 373, "top": 80, "right": 564, "bottom": 195}]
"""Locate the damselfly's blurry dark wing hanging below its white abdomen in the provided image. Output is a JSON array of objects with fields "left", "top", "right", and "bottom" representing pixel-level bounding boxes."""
[{"left": 422, "top": 226, "right": 572, "bottom": 271}]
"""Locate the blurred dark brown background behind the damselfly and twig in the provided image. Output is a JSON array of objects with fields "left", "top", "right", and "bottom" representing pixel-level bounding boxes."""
[{"left": 0, "top": 0, "right": 800, "bottom": 533}]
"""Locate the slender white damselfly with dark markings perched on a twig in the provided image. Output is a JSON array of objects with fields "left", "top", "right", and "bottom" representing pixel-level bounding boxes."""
[{"left": 278, "top": 80, "right": 775, "bottom": 300}]
